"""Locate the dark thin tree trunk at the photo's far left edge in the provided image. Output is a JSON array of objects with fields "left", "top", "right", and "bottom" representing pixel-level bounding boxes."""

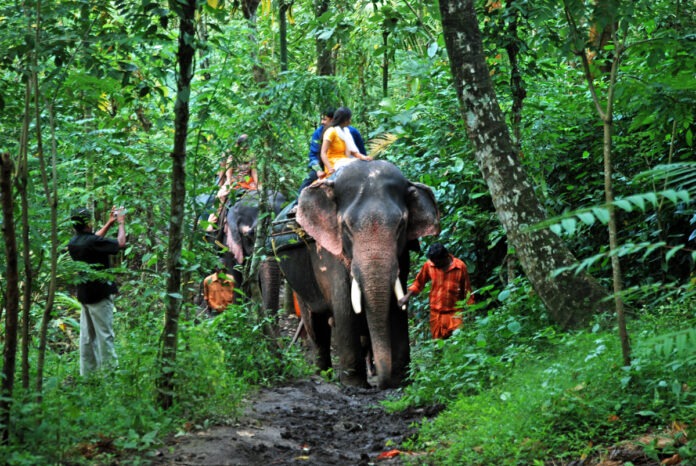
[{"left": 0, "top": 153, "right": 19, "bottom": 444}]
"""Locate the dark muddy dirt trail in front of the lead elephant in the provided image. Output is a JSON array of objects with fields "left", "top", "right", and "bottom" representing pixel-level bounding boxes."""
[{"left": 153, "top": 377, "right": 438, "bottom": 466}]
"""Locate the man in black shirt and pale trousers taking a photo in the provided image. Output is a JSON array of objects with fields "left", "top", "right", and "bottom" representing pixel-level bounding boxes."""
[{"left": 68, "top": 207, "right": 126, "bottom": 375}]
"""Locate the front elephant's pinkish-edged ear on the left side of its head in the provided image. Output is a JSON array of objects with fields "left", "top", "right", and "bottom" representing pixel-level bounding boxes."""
[{"left": 296, "top": 180, "right": 343, "bottom": 257}]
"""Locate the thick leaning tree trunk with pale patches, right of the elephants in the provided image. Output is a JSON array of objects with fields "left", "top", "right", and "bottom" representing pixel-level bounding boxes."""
[{"left": 440, "top": 0, "right": 607, "bottom": 327}]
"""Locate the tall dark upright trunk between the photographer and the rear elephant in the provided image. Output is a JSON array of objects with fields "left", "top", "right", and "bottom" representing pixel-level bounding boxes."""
[{"left": 157, "top": 0, "right": 196, "bottom": 409}]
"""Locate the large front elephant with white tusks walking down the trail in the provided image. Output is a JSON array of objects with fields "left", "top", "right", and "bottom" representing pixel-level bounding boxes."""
[{"left": 272, "top": 160, "right": 440, "bottom": 389}]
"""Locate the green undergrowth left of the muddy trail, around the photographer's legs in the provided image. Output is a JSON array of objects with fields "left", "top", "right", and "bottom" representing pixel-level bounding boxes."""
[{"left": 0, "top": 303, "right": 308, "bottom": 465}]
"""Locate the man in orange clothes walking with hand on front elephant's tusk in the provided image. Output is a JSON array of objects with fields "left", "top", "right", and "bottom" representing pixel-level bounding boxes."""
[{"left": 399, "top": 243, "right": 474, "bottom": 339}]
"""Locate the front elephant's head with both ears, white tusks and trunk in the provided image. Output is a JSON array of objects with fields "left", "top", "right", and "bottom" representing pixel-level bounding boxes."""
[{"left": 296, "top": 161, "right": 440, "bottom": 388}]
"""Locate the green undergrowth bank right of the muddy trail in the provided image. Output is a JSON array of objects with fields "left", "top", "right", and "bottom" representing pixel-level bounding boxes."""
[{"left": 387, "top": 290, "right": 696, "bottom": 465}]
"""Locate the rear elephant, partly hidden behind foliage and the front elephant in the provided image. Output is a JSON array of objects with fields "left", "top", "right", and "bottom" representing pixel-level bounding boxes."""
[{"left": 223, "top": 191, "right": 285, "bottom": 311}]
